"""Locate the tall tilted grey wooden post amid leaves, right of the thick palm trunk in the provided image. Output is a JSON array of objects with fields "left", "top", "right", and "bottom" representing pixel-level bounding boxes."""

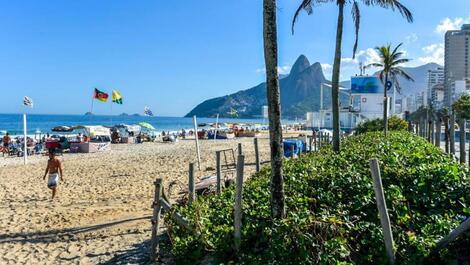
[{"left": 369, "top": 159, "right": 395, "bottom": 264}]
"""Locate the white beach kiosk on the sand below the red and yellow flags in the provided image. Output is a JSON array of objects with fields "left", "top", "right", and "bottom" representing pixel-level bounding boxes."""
[{"left": 70, "top": 126, "right": 111, "bottom": 153}]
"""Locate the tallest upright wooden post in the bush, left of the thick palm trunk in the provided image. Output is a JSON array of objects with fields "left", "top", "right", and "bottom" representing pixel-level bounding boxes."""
[{"left": 233, "top": 155, "right": 245, "bottom": 251}]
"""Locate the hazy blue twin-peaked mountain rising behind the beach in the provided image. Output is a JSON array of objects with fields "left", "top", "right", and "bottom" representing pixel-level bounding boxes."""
[{"left": 186, "top": 55, "right": 440, "bottom": 118}]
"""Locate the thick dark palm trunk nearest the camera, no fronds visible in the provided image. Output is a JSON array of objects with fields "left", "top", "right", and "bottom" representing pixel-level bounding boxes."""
[{"left": 263, "top": 0, "right": 285, "bottom": 219}]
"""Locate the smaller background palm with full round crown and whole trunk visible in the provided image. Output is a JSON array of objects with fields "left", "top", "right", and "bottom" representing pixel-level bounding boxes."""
[{"left": 368, "top": 43, "right": 414, "bottom": 136}]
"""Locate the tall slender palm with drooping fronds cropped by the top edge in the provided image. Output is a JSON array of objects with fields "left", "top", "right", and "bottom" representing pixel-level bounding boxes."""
[{"left": 292, "top": 0, "right": 413, "bottom": 152}]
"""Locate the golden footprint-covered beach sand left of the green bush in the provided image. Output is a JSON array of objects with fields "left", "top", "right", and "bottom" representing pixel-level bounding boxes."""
[{"left": 0, "top": 138, "right": 269, "bottom": 264}]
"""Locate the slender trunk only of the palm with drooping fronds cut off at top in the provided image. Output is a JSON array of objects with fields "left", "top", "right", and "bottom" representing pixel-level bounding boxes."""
[{"left": 331, "top": 1, "right": 344, "bottom": 152}]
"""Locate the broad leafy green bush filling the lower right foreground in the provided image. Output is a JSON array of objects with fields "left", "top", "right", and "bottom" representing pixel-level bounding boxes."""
[{"left": 167, "top": 132, "right": 470, "bottom": 264}]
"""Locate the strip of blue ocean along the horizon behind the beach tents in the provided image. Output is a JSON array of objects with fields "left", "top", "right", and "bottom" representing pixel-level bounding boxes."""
[{"left": 0, "top": 114, "right": 276, "bottom": 135}]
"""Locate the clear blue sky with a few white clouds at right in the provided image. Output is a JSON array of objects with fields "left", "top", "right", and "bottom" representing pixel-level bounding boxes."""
[{"left": 0, "top": 0, "right": 470, "bottom": 116}]
